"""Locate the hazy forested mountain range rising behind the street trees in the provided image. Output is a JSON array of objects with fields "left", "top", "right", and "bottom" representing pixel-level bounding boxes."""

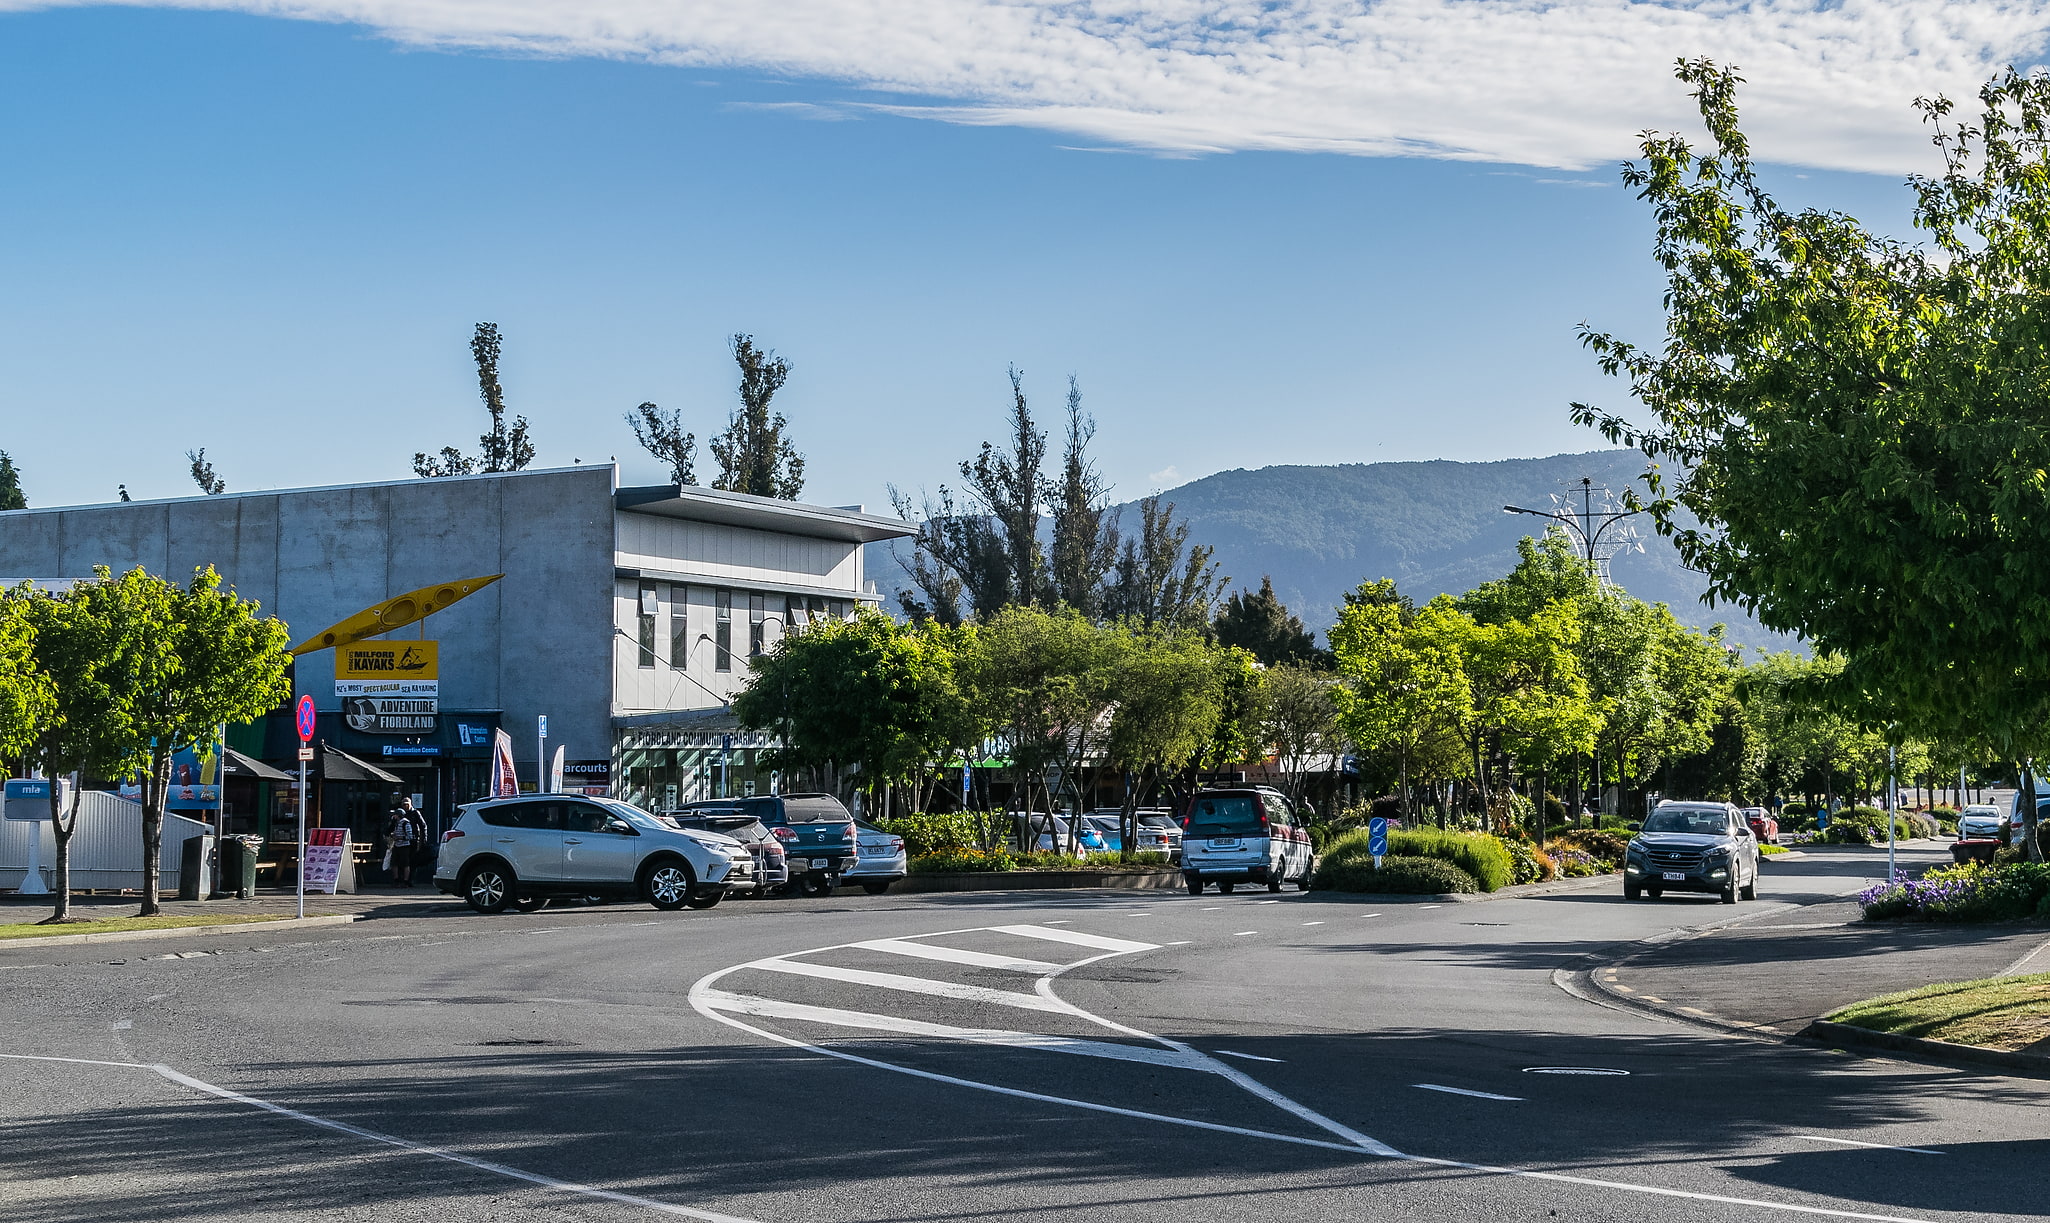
[{"left": 867, "top": 451, "right": 1788, "bottom": 649}]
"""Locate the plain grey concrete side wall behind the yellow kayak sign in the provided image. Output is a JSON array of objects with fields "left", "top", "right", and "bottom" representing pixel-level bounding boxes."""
[{"left": 0, "top": 467, "right": 613, "bottom": 760}]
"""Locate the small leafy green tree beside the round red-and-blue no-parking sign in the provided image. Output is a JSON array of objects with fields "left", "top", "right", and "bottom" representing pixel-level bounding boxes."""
[{"left": 121, "top": 565, "right": 291, "bottom": 918}]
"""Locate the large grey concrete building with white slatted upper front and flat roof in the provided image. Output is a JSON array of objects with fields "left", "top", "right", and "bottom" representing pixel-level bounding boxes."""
[{"left": 0, "top": 465, "right": 910, "bottom": 828}]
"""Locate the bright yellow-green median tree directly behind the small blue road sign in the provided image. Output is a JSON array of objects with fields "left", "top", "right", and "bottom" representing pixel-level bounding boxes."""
[{"left": 1330, "top": 582, "right": 1472, "bottom": 819}]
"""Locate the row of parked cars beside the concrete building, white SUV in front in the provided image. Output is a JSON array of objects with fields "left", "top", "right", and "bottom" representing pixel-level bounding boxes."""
[{"left": 435, "top": 795, "right": 906, "bottom": 914}]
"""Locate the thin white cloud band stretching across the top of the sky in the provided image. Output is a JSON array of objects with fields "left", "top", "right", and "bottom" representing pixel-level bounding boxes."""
[{"left": 24, "top": 0, "right": 2050, "bottom": 172}]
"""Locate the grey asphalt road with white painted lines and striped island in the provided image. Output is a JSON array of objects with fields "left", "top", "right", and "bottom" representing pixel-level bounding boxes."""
[{"left": 0, "top": 854, "right": 2050, "bottom": 1223}]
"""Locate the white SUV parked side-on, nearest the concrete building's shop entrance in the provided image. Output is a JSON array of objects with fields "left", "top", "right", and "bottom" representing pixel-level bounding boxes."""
[{"left": 435, "top": 795, "right": 754, "bottom": 914}]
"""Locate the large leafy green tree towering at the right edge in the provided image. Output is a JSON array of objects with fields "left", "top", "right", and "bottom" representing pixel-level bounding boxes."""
[{"left": 1572, "top": 59, "right": 2050, "bottom": 856}]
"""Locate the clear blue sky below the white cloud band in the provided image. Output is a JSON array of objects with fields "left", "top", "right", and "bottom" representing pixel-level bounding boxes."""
[{"left": 0, "top": 0, "right": 1984, "bottom": 508}]
